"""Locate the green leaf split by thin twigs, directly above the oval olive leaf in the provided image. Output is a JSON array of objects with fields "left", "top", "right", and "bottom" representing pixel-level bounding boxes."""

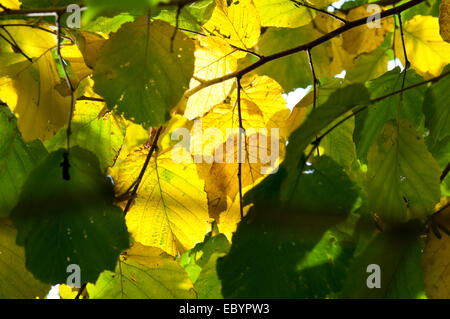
[{"left": 353, "top": 67, "right": 426, "bottom": 163}]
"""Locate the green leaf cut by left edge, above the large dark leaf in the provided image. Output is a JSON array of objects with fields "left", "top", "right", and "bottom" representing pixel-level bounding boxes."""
[{"left": 0, "top": 106, "right": 47, "bottom": 217}]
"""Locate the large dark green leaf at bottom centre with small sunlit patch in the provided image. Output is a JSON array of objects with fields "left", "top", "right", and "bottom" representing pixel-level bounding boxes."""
[{"left": 217, "top": 157, "right": 358, "bottom": 298}]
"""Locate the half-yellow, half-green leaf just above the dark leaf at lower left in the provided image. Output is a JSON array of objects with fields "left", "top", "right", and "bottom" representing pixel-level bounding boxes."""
[{"left": 45, "top": 101, "right": 126, "bottom": 169}]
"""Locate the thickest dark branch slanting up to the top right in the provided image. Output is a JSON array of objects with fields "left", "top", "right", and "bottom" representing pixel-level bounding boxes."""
[{"left": 185, "top": 0, "right": 425, "bottom": 97}]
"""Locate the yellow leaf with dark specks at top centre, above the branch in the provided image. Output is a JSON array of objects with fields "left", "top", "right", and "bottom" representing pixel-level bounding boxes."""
[{"left": 203, "top": 0, "right": 261, "bottom": 50}]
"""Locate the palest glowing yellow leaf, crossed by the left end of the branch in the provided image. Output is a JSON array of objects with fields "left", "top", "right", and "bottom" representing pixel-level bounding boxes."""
[{"left": 184, "top": 37, "right": 237, "bottom": 120}]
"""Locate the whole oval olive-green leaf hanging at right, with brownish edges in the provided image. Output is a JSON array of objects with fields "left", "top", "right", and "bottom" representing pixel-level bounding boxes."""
[{"left": 367, "top": 120, "right": 441, "bottom": 223}]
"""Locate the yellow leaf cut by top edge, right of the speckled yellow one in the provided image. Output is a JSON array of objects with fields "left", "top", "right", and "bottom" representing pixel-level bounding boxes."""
[{"left": 254, "top": 0, "right": 313, "bottom": 28}]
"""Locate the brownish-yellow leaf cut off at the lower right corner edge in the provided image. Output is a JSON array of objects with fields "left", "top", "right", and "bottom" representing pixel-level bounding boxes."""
[{"left": 421, "top": 208, "right": 450, "bottom": 299}]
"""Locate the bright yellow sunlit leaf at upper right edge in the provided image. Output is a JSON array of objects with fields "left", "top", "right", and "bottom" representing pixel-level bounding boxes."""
[{"left": 395, "top": 15, "right": 450, "bottom": 79}]
